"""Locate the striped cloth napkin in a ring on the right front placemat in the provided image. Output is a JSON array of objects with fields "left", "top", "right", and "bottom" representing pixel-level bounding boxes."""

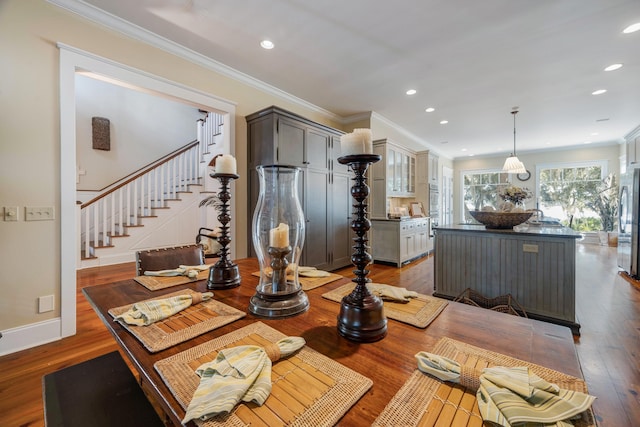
[{"left": 416, "top": 351, "right": 595, "bottom": 427}]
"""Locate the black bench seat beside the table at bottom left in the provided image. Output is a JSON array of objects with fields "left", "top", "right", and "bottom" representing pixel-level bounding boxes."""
[{"left": 42, "top": 351, "right": 164, "bottom": 427}]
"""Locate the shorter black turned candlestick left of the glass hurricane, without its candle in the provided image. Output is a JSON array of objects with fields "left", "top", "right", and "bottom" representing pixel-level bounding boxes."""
[{"left": 207, "top": 173, "right": 241, "bottom": 289}]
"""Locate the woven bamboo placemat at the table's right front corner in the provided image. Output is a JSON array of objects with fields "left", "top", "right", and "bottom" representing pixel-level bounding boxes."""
[{"left": 373, "top": 338, "right": 595, "bottom": 427}]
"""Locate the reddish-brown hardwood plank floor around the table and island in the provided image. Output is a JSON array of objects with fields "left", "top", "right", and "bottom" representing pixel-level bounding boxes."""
[{"left": 0, "top": 244, "right": 640, "bottom": 427}]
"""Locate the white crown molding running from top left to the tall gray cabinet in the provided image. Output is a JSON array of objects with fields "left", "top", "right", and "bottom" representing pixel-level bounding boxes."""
[{"left": 46, "top": 0, "right": 344, "bottom": 123}]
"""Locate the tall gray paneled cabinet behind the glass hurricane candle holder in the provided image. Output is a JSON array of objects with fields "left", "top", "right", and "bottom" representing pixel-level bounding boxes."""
[{"left": 246, "top": 106, "right": 352, "bottom": 270}]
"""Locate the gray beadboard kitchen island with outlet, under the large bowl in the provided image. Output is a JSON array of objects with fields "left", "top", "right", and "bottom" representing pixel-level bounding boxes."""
[{"left": 434, "top": 225, "right": 581, "bottom": 335}]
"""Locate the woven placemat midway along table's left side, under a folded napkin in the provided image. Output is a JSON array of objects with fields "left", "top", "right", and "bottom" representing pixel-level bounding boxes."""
[{"left": 109, "top": 289, "right": 246, "bottom": 353}]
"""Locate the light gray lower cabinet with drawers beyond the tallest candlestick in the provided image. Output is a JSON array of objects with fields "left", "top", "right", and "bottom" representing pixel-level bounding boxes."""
[{"left": 370, "top": 218, "right": 432, "bottom": 267}]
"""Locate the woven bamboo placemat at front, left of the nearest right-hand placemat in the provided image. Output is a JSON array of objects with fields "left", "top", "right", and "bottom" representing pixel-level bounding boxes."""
[{"left": 155, "top": 322, "right": 373, "bottom": 427}]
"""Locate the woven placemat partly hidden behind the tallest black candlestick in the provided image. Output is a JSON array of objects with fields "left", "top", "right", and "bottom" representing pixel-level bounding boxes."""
[{"left": 322, "top": 283, "right": 449, "bottom": 328}]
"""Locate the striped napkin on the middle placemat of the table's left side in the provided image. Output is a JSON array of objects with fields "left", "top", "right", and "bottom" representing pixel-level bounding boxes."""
[{"left": 115, "top": 292, "right": 213, "bottom": 326}]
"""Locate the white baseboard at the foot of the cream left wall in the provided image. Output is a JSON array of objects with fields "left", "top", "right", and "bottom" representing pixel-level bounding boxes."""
[{"left": 0, "top": 317, "right": 62, "bottom": 356}]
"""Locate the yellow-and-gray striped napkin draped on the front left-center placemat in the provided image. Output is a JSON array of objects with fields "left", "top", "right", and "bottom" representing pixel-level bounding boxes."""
[{"left": 182, "top": 337, "right": 305, "bottom": 424}]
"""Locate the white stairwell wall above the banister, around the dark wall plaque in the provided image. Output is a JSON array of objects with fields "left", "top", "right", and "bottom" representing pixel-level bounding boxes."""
[{"left": 75, "top": 74, "right": 203, "bottom": 190}]
